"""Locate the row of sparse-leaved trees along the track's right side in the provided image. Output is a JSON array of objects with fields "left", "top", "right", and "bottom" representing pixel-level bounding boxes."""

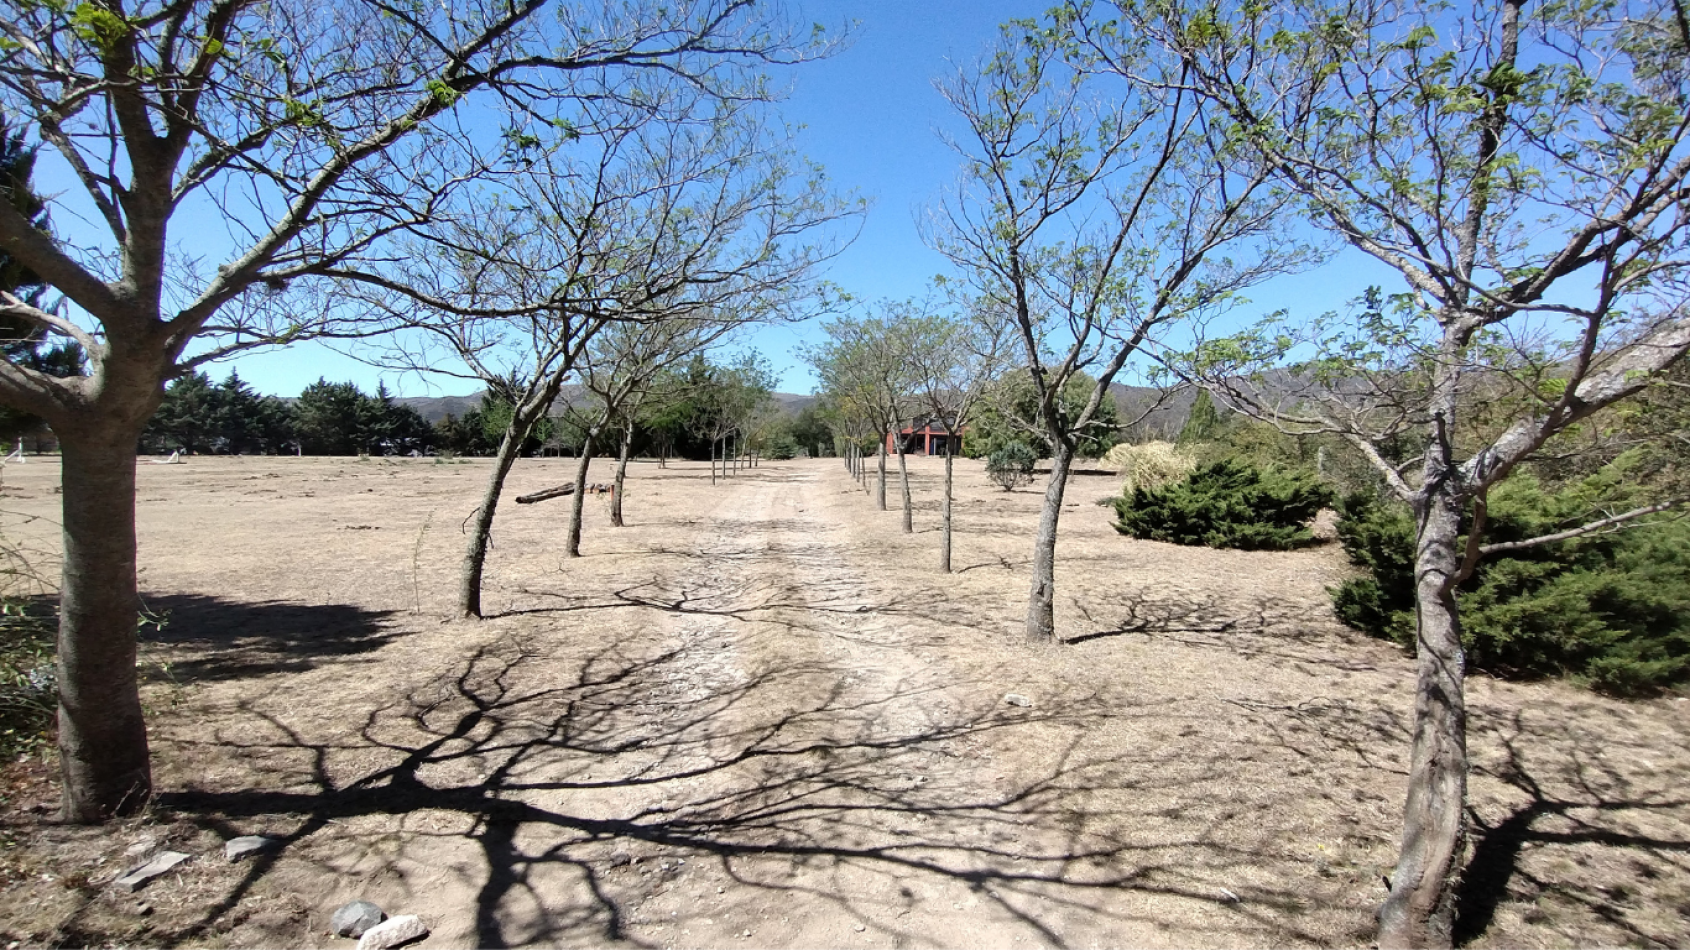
[{"left": 797, "top": 0, "right": 1690, "bottom": 947}]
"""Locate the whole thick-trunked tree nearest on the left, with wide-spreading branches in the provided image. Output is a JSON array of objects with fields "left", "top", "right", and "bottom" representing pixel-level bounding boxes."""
[{"left": 0, "top": 0, "right": 841, "bottom": 822}]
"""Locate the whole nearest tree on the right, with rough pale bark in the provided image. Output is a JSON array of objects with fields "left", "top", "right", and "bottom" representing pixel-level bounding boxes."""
[{"left": 1114, "top": 0, "right": 1690, "bottom": 947}]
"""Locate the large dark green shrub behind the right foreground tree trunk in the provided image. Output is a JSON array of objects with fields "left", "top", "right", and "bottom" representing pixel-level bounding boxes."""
[{"left": 1333, "top": 465, "right": 1690, "bottom": 695}]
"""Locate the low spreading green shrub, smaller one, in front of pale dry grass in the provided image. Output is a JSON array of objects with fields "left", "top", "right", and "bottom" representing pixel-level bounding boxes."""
[{"left": 1115, "top": 460, "right": 1332, "bottom": 551}]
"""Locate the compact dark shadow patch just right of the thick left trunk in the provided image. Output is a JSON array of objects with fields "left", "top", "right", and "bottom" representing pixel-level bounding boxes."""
[{"left": 140, "top": 593, "right": 397, "bottom": 683}]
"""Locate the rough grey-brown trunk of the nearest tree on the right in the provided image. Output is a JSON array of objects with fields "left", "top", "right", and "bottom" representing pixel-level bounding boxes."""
[{"left": 1379, "top": 485, "right": 1467, "bottom": 950}]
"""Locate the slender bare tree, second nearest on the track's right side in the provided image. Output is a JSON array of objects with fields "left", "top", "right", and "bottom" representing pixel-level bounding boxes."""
[{"left": 928, "top": 10, "right": 1305, "bottom": 642}]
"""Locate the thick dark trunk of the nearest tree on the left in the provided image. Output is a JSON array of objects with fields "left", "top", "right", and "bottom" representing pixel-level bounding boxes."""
[{"left": 57, "top": 426, "right": 152, "bottom": 823}]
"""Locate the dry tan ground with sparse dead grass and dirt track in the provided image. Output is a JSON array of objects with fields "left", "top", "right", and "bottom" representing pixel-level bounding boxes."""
[{"left": 0, "top": 458, "right": 1690, "bottom": 947}]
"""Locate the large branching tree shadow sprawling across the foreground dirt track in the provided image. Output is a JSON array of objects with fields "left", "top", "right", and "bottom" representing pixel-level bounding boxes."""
[{"left": 154, "top": 637, "right": 1320, "bottom": 947}]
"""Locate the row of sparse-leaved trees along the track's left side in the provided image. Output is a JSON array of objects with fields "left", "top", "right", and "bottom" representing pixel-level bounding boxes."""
[{"left": 0, "top": 0, "right": 859, "bottom": 822}]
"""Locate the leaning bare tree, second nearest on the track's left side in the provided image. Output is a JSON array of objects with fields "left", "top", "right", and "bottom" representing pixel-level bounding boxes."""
[{"left": 361, "top": 88, "right": 845, "bottom": 617}]
